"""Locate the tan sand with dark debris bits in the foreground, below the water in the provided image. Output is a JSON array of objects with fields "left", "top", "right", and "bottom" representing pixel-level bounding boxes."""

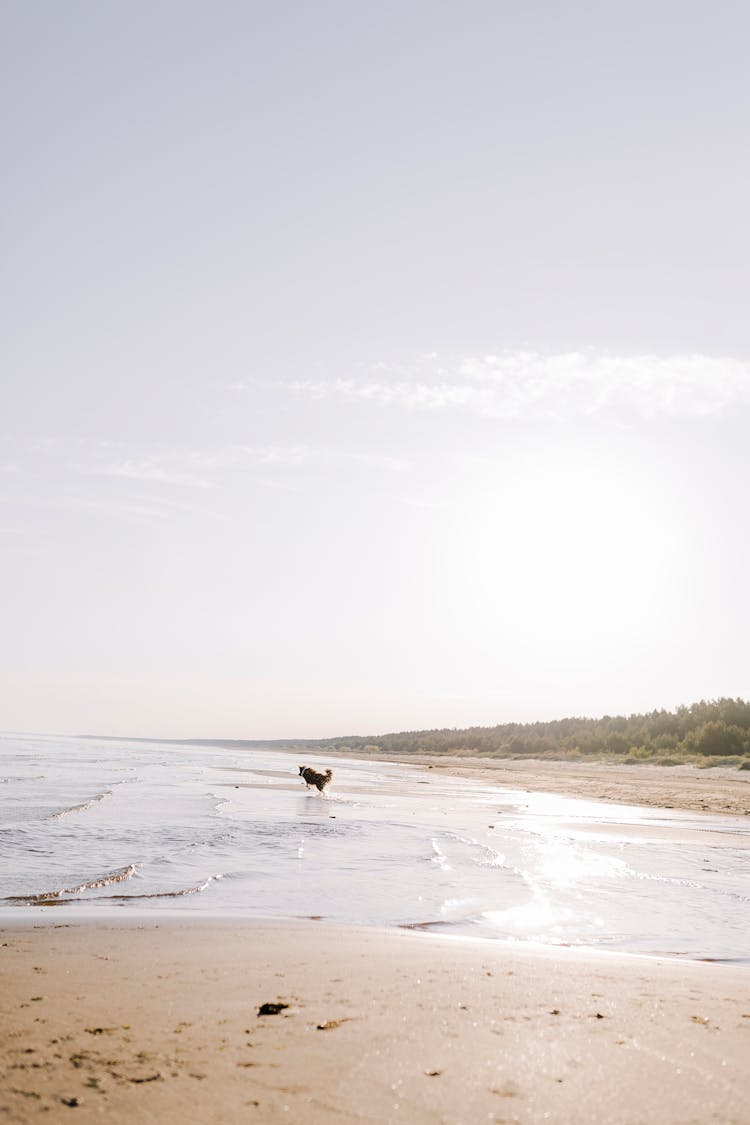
[{"left": 0, "top": 916, "right": 750, "bottom": 1125}]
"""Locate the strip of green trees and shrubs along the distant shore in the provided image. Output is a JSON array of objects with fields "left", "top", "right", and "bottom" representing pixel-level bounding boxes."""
[{"left": 275, "top": 699, "right": 750, "bottom": 770}]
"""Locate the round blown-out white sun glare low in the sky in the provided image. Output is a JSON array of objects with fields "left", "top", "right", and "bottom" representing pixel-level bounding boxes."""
[{"left": 434, "top": 445, "right": 679, "bottom": 653}]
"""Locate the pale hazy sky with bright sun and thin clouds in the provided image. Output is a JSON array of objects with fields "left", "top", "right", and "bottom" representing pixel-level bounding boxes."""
[{"left": 0, "top": 0, "right": 750, "bottom": 738}]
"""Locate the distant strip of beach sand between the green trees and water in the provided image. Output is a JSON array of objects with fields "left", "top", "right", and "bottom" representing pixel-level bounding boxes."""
[{"left": 366, "top": 755, "right": 750, "bottom": 817}]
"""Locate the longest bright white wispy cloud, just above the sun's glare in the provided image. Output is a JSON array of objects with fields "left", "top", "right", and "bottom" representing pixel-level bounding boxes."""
[{"left": 288, "top": 351, "right": 750, "bottom": 419}]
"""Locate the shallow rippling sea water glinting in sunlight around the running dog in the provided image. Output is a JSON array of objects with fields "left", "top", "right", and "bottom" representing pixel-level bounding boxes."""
[{"left": 0, "top": 736, "right": 750, "bottom": 963}]
